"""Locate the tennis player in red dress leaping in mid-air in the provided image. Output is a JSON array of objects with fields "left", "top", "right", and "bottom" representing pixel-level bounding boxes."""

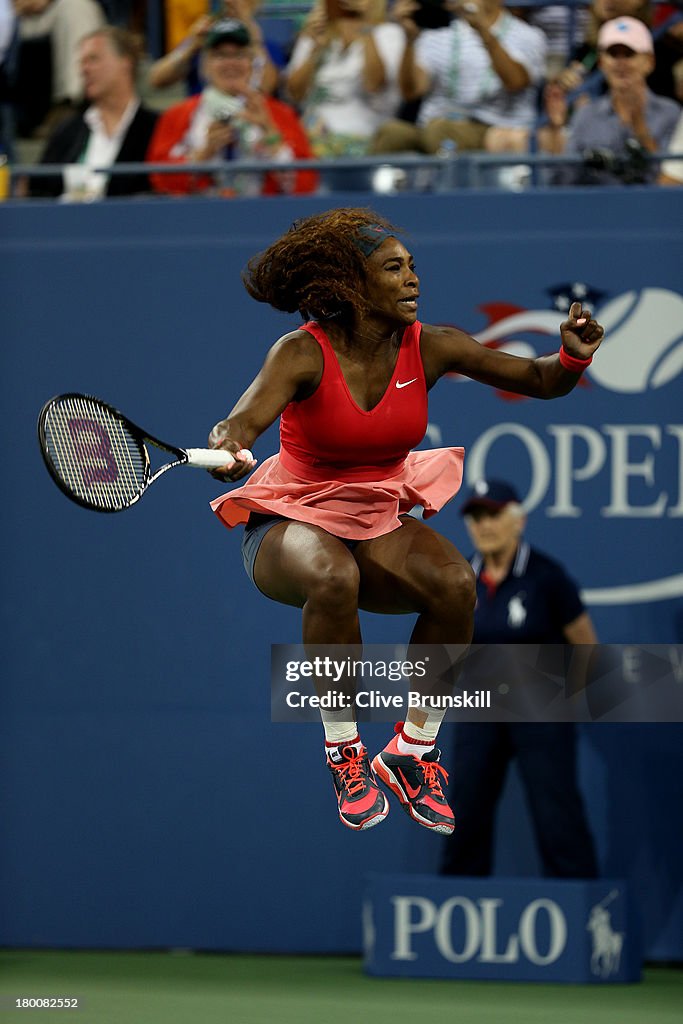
[{"left": 209, "top": 208, "right": 603, "bottom": 835}]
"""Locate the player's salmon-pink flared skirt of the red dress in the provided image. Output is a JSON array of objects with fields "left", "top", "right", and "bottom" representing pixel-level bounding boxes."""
[{"left": 211, "top": 447, "right": 465, "bottom": 541}]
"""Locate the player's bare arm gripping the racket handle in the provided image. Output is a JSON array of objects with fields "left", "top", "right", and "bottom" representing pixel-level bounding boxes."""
[{"left": 209, "top": 331, "right": 323, "bottom": 480}]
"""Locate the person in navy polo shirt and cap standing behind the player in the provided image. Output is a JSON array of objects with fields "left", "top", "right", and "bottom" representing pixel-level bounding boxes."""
[{"left": 441, "top": 480, "right": 597, "bottom": 879}]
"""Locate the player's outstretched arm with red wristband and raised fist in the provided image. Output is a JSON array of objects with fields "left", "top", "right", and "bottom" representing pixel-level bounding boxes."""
[{"left": 422, "top": 302, "right": 604, "bottom": 398}]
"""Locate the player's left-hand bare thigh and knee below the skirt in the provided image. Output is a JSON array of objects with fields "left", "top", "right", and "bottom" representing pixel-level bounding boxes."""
[{"left": 254, "top": 519, "right": 355, "bottom": 608}]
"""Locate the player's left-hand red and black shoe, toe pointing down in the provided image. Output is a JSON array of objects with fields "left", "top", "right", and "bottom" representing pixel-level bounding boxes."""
[{"left": 328, "top": 743, "right": 389, "bottom": 830}]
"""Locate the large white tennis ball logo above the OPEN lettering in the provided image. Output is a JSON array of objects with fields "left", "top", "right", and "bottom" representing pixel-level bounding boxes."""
[{"left": 589, "top": 288, "right": 683, "bottom": 394}]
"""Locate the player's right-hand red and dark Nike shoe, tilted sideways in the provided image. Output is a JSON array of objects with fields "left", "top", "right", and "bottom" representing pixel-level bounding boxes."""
[{"left": 373, "top": 736, "right": 455, "bottom": 836}]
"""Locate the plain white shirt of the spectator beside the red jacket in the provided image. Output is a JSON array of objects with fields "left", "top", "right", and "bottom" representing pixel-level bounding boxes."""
[{"left": 285, "top": 22, "right": 405, "bottom": 138}]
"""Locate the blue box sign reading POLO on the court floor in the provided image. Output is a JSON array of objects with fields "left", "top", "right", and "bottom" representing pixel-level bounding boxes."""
[{"left": 364, "top": 874, "right": 641, "bottom": 984}]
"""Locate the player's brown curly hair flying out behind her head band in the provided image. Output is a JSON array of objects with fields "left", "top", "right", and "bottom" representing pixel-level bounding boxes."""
[{"left": 242, "top": 207, "right": 397, "bottom": 326}]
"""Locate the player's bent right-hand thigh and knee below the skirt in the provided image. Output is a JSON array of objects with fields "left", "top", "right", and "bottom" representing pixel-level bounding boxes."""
[{"left": 354, "top": 516, "right": 471, "bottom": 614}]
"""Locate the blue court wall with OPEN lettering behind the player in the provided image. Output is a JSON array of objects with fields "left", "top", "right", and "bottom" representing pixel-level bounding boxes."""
[{"left": 0, "top": 188, "right": 683, "bottom": 959}]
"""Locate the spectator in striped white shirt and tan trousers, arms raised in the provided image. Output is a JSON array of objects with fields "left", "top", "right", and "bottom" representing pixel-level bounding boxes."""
[{"left": 372, "top": 0, "right": 547, "bottom": 154}]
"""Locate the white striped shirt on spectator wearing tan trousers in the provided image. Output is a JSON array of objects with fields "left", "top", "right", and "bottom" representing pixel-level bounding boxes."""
[{"left": 416, "top": 11, "right": 548, "bottom": 128}]
